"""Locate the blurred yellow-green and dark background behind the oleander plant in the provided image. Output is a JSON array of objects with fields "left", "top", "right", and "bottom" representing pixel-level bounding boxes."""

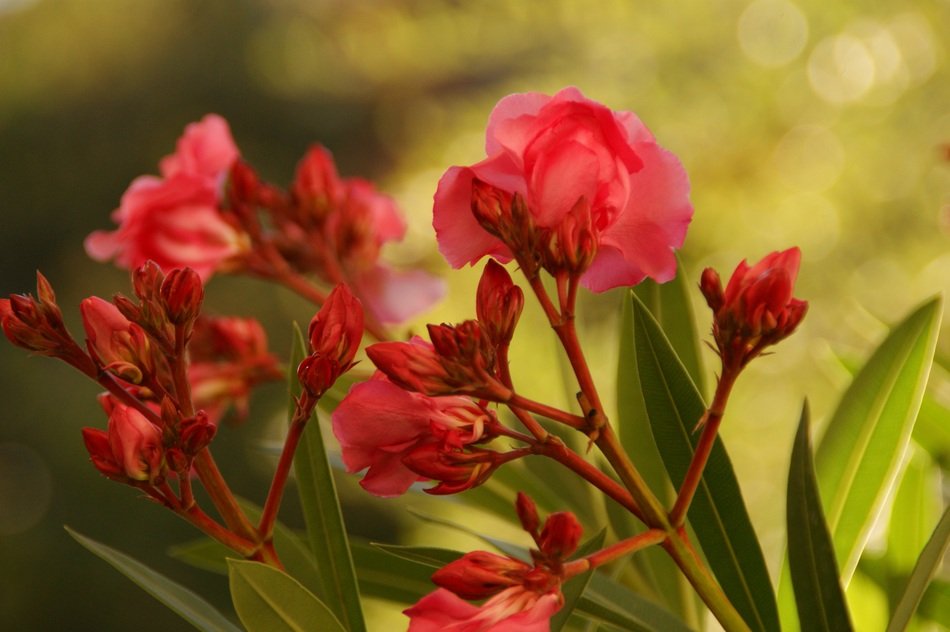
[{"left": 0, "top": 0, "right": 950, "bottom": 631}]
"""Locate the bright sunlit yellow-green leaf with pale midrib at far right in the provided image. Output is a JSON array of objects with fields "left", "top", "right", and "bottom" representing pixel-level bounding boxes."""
[{"left": 815, "top": 299, "right": 941, "bottom": 585}]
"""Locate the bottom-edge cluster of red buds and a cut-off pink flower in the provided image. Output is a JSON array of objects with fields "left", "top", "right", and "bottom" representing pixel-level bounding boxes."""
[{"left": 405, "top": 493, "right": 582, "bottom": 632}]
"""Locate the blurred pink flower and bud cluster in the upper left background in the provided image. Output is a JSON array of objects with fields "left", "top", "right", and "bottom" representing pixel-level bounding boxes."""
[{"left": 86, "top": 114, "right": 444, "bottom": 330}]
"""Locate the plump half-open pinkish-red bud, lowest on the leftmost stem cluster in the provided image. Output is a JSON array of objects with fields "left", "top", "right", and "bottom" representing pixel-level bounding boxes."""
[{"left": 82, "top": 402, "right": 165, "bottom": 484}]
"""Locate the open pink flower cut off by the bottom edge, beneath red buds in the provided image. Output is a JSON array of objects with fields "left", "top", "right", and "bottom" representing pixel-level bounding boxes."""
[{"left": 403, "top": 585, "right": 564, "bottom": 632}]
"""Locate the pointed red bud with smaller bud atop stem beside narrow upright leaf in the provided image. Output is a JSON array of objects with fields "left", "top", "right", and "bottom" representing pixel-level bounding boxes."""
[{"left": 297, "top": 285, "right": 363, "bottom": 399}]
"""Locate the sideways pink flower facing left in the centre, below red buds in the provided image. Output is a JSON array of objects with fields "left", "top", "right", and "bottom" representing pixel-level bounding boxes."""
[{"left": 333, "top": 372, "right": 494, "bottom": 497}]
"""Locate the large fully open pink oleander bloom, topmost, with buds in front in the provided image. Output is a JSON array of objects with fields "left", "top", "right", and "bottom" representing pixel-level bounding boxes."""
[{"left": 433, "top": 88, "right": 693, "bottom": 292}]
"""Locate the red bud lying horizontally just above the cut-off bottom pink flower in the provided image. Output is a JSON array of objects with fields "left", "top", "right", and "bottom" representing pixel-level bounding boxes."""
[{"left": 432, "top": 551, "right": 531, "bottom": 600}]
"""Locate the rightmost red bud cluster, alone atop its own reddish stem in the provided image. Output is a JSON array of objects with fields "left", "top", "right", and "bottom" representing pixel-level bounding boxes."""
[{"left": 700, "top": 248, "right": 808, "bottom": 371}]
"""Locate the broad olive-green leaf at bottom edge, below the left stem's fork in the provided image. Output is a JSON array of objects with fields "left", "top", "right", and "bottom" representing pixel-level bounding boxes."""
[{"left": 228, "top": 559, "right": 345, "bottom": 632}]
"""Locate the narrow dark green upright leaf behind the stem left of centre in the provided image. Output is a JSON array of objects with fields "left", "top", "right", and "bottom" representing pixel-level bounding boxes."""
[{"left": 289, "top": 325, "right": 366, "bottom": 632}]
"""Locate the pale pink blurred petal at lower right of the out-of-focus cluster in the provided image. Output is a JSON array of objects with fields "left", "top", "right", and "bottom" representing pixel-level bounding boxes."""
[{"left": 354, "top": 265, "right": 446, "bottom": 323}]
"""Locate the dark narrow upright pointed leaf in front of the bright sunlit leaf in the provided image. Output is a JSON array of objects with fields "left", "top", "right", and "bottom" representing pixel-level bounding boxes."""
[{"left": 785, "top": 403, "right": 853, "bottom": 632}]
